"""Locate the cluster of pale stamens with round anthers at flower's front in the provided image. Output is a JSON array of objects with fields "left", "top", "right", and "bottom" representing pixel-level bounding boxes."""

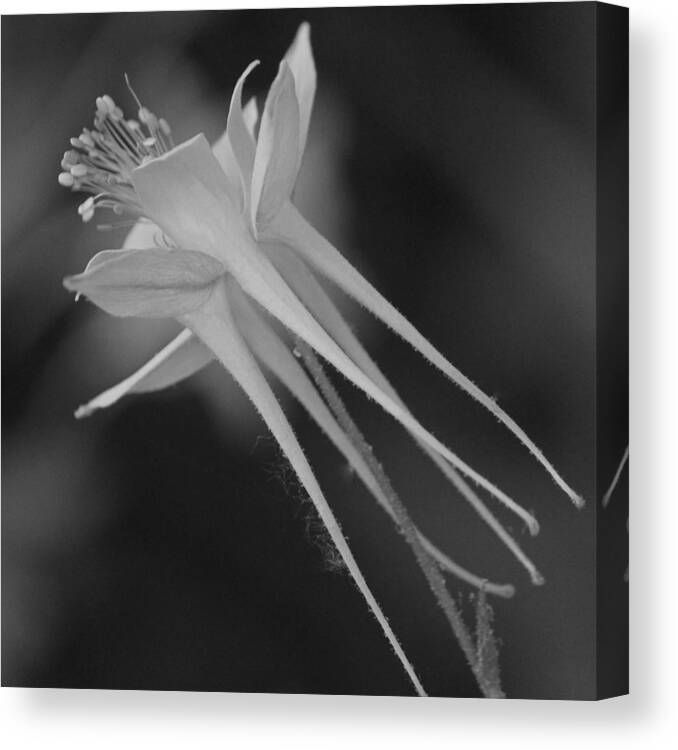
[{"left": 59, "top": 88, "right": 174, "bottom": 221}]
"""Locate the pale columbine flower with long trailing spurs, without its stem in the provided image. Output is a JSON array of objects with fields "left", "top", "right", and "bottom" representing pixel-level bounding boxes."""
[{"left": 59, "top": 24, "right": 581, "bottom": 692}]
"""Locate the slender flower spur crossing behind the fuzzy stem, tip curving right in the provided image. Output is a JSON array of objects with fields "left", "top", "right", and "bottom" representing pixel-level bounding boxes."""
[{"left": 229, "top": 288, "right": 514, "bottom": 597}]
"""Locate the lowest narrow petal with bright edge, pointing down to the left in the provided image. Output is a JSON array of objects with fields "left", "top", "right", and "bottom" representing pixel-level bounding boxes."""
[{"left": 75, "top": 329, "right": 214, "bottom": 419}]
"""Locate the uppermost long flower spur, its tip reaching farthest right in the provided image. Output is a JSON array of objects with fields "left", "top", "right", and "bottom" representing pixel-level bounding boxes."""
[{"left": 269, "top": 203, "right": 584, "bottom": 507}]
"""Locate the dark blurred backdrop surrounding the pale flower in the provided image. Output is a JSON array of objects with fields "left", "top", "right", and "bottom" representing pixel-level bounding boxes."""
[{"left": 2, "top": 3, "right": 628, "bottom": 698}]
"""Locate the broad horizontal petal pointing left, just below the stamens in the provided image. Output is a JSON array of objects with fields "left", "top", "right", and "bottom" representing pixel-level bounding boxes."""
[{"left": 64, "top": 248, "right": 225, "bottom": 318}]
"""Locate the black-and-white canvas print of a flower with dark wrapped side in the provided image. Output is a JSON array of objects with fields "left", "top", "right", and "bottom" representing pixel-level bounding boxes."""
[{"left": 2, "top": 2, "right": 629, "bottom": 700}]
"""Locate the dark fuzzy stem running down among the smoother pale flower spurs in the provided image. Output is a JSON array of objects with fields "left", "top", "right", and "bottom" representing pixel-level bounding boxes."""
[{"left": 295, "top": 338, "right": 504, "bottom": 698}]
